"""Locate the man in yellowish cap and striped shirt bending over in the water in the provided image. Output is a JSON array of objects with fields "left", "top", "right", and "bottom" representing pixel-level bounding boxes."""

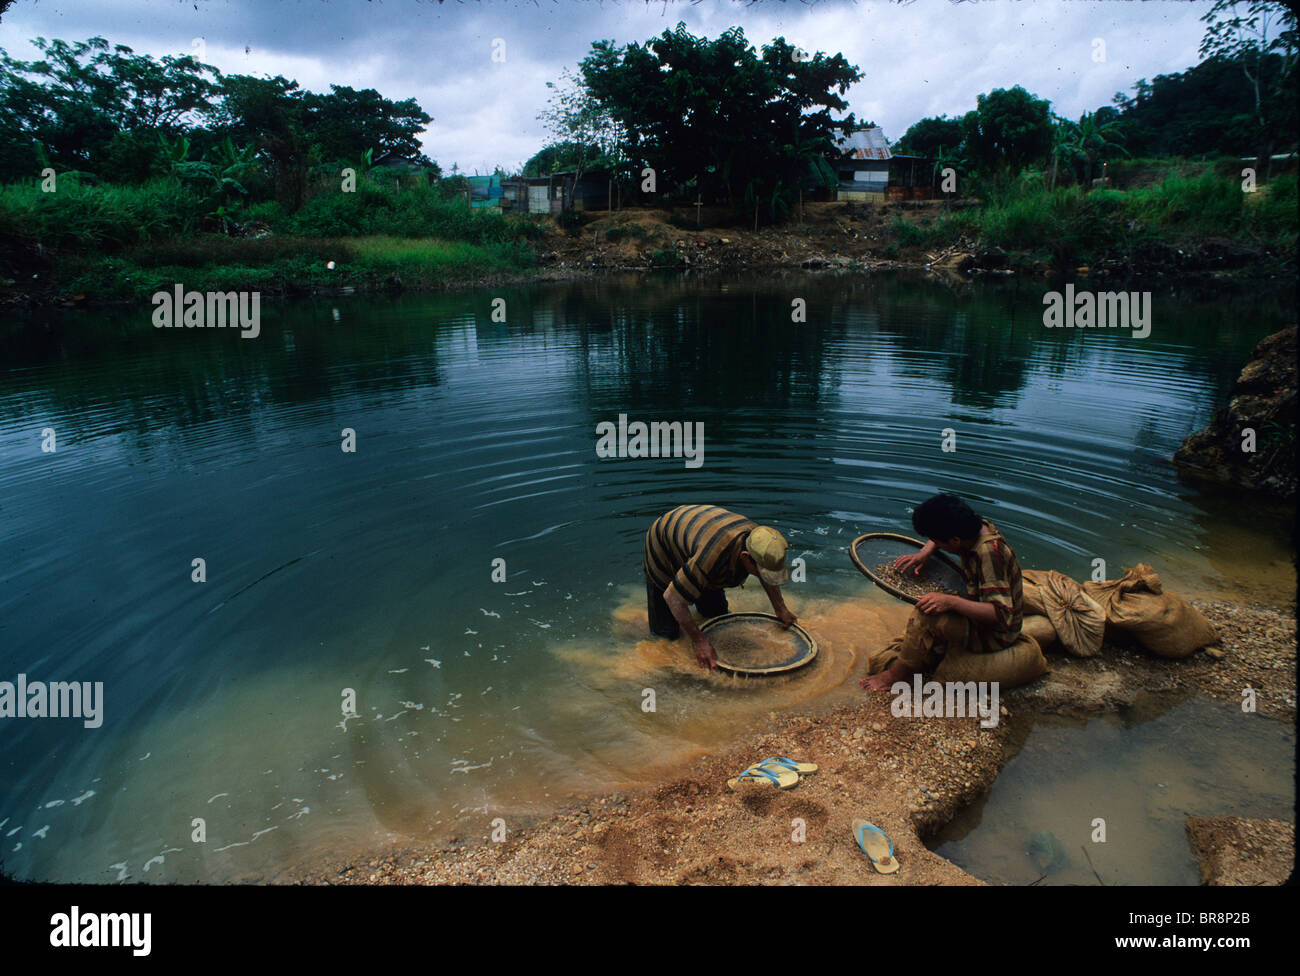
[{"left": 644, "top": 506, "right": 796, "bottom": 671}]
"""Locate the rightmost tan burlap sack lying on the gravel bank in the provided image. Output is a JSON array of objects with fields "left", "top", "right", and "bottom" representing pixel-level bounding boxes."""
[{"left": 1083, "top": 563, "right": 1219, "bottom": 658}]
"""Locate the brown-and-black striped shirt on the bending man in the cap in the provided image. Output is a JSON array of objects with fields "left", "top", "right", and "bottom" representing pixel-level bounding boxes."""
[{"left": 645, "top": 506, "right": 758, "bottom": 603}]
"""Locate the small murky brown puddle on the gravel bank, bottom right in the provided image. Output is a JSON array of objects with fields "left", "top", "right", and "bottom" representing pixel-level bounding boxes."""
[{"left": 931, "top": 699, "right": 1295, "bottom": 885}]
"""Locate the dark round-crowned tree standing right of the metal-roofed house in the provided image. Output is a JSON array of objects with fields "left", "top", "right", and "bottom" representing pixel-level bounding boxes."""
[{"left": 962, "top": 84, "right": 1052, "bottom": 182}]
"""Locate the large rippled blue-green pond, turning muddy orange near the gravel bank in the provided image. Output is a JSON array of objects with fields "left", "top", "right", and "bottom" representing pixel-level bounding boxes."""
[{"left": 0, "top": 274, "right": 1295, "bottom": 881}]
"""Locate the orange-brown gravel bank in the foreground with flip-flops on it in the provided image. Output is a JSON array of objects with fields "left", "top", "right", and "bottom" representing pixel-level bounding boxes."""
[{"left": 298, "top": 602, "right": 1296, "bottom": 885}]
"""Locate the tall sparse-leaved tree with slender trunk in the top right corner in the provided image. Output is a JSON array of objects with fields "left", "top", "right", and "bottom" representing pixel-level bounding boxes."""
[{"left": 1200, "top": 0, "right": 1300, "bottom": 179}]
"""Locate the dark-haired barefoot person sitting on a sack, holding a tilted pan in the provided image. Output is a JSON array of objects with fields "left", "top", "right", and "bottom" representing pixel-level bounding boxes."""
[{"left": 861, "top": 495, "right": 1024, "bottom": 691}]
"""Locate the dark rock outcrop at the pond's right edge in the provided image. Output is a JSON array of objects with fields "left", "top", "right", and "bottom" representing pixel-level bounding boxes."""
[{"left": 1174, "top": 326, "right": 1296, "bottom": 499}]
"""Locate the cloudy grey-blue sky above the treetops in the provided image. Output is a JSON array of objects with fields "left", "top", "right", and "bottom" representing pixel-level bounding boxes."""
[{"left": 0, "top": 0, "right": 1208, "bottom": 173}]
